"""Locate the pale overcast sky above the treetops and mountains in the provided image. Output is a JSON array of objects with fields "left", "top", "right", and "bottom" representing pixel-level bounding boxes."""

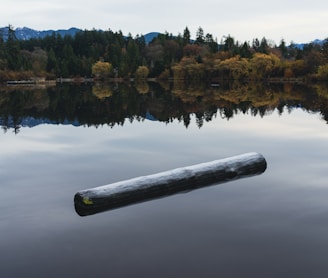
[{"left": 0, "top": 0, "right": 328, "bottom": 44}]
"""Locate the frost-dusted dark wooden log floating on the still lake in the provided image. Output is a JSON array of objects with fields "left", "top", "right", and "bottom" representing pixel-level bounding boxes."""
[{"left": 74, "top": 153, "right": 267, "bottom": 216}]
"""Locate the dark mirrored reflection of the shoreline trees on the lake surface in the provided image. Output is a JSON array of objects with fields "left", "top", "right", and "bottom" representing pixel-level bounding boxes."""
[{"left": 0, "top": 82, "right": 328, "bottom": 132}]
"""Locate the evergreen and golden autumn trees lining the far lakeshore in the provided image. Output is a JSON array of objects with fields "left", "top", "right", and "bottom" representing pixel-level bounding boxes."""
[{"left": 0, "top": 26, "right": 328, "bottom": 80}]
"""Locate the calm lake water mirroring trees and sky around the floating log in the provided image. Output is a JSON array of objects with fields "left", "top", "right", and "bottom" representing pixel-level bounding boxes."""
[{"left": 0, "top": 82, "right": 328, "bottom": 277}]
